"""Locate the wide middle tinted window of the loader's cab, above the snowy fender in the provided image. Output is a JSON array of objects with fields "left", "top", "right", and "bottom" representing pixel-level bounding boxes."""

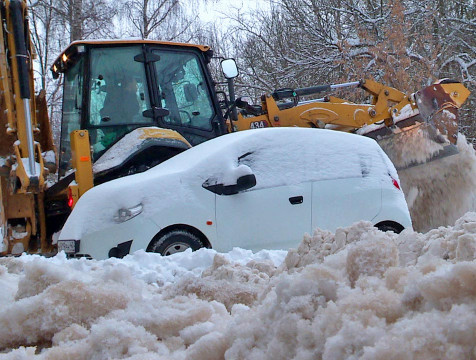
[{"left": 87, "top": 46, "right": 153, "bottom": 159}]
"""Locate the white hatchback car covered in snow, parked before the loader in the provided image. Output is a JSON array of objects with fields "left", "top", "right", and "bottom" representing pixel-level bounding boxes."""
[{"left": 58, "top": 128, "right": 412, "bottom": 259}]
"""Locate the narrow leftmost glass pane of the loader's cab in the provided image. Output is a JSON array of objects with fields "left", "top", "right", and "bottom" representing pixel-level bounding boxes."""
[{"left": 59, "top": 59, "right": 83, "bottom": 178}]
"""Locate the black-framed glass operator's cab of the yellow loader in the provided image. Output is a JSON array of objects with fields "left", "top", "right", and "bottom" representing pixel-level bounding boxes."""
[{"left": 52, "top": 40, "right": 226, "bottom": 177}]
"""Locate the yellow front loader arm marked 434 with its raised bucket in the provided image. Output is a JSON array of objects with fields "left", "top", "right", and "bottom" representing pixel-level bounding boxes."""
[{"left": 230, "top": 80, "right": 470, "bottom": 168}]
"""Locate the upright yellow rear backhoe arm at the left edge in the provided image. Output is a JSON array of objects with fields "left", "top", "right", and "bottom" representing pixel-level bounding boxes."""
[{"left": 0, "top": 0, "right": 55, "bottom": 254}]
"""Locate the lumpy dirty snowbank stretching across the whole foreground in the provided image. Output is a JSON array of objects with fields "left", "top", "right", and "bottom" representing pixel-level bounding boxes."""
[{"left": 0, "top": 213, "right": 476, "bottom": 360}]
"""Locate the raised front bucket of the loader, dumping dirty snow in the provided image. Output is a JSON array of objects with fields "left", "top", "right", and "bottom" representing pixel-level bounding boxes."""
[{"left": 365, "top": 79, "right": 470, "bottom": 170}]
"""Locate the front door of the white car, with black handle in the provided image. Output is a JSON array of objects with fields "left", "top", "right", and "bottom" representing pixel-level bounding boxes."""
[{"left": 216, "top": 148, "right": 311, "bottom": 250}]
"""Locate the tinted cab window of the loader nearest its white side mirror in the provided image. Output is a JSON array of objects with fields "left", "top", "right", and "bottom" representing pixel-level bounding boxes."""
[{"left": 154, "top": 50, "right": 215, "bottom": 136}]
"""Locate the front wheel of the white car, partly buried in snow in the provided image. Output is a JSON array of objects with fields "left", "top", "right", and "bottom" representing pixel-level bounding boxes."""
[{"left": 150, "top": 230, "right": 204, "bottom": 256}]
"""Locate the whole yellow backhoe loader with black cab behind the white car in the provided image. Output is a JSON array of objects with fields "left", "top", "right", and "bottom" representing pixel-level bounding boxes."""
[{"left": 0, "top": 0, "right": 469, "bottom": 255}]
